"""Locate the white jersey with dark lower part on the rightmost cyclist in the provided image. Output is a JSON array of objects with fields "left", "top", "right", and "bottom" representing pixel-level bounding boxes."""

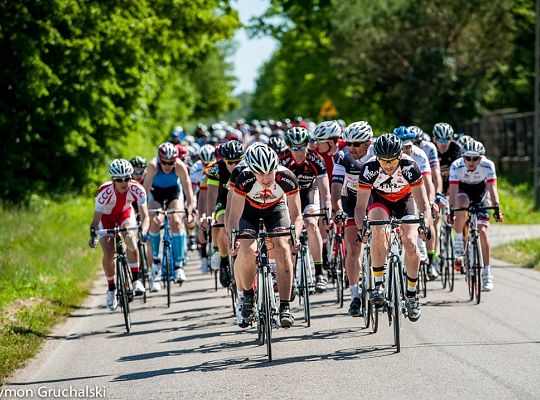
[{"left": 449, "top": 157, "right": 497, "bottom": 204}]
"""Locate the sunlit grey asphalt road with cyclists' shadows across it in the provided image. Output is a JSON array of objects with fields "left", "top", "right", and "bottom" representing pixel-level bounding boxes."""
[{"left": 3, "top": 227, "right": 540, "bottom": 399}]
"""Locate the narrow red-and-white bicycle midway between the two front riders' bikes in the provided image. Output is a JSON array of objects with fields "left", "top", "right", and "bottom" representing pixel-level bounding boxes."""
[{"left": 328, "top": 211, "right": 347, "bottom": 308}]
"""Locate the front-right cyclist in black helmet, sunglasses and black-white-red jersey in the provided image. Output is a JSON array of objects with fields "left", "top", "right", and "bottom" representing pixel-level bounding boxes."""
[{"left": 355, "top": 133, "right": 431, "bottom": 321}]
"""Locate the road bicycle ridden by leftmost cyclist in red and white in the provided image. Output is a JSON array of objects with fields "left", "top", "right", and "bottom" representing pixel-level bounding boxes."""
[{"left": 93, "top": 226, "right": 140, "bottom": 333}]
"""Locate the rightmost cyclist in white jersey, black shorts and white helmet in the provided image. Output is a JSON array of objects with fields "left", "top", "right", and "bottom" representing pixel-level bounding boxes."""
[{"left": 448, "top": 140, "right": 503, "bottom": 291}]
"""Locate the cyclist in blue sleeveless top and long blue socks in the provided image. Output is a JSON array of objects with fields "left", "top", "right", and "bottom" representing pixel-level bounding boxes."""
[{"left": 144, "top": 143, "right": 194, "bottom": 290}]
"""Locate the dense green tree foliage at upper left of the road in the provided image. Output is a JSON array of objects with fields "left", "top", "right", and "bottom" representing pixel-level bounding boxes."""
[{"left": 0, "top": 0, "right": 239, "bottom": 202}]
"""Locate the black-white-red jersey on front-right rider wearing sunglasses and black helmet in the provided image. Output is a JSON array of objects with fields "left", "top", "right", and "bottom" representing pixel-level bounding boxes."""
[{"left": 358, "top": 154, "right": 423, "bottom": 202}]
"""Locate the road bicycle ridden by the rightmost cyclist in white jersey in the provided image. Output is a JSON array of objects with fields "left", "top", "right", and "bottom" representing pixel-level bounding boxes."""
[{"left": 451, "top": 204, "right": 499, "bottom": 304}]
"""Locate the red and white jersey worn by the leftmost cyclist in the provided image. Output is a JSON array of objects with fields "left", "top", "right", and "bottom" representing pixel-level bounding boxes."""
[{"left": 95, "top": 180, "right": 146, "bottom": 229}]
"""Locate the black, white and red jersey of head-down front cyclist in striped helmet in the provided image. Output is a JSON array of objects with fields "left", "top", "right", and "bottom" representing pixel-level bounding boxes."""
[{"left": 234, "top": 165, "right": 299, "bottom": 210}]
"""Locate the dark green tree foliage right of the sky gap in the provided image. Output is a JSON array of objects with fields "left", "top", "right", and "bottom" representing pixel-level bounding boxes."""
[{"left": 252, "top": 0, "right": 535, "bottom": 131}]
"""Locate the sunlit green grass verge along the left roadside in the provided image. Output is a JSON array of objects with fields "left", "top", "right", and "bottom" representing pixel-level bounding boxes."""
[{"left": 0, "top": 197, "right": 100, "bottom": 385}]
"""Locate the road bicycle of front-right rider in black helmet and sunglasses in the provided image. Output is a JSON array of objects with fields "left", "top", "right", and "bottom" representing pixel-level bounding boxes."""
[{"left": 362, "top": 214, "right": 431, "bottom": 353}]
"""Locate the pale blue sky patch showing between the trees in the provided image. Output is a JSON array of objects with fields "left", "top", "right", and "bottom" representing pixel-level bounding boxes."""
[{"left": 231, "top": 0, "right": 276, "bottom": 94}]
